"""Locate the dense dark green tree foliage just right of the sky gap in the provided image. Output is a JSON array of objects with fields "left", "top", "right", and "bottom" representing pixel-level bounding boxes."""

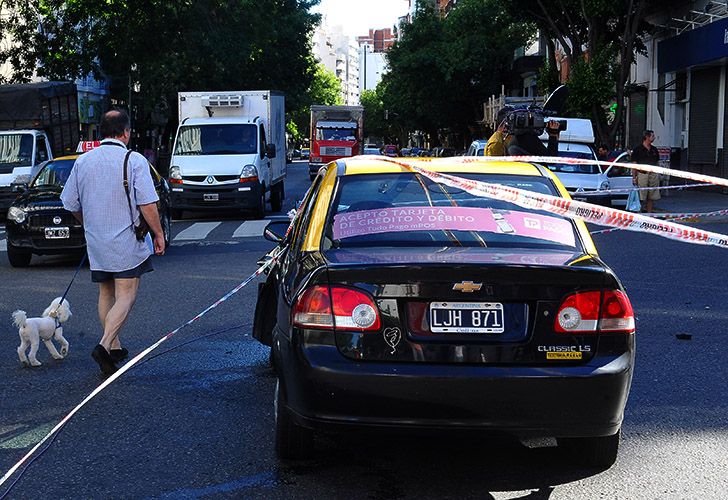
[{"left": 382, "top": 0, "right": 534, "bottom": 146}]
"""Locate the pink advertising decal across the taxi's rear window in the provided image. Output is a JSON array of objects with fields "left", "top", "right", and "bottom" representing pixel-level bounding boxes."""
[{"left": 333, "top": 206, "right": 575, "bottom": 247}]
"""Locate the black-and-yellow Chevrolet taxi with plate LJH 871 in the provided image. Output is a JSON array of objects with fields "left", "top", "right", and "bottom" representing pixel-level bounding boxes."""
[{"left": 253, "top": 158, "right": 635, "bottom": 466}]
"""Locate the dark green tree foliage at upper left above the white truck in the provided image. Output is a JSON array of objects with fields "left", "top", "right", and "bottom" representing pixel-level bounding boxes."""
[{"left": 0, "top": 0, "right": 319, "bottom": 133}]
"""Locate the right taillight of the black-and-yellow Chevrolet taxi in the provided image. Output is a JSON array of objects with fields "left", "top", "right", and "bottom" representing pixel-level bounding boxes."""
[{"left": 554, "top": 290, "right": 634, "bottom": 333}]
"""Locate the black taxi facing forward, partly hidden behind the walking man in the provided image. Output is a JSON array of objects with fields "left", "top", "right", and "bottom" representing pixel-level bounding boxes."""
[{"left": 5, "top": 154, "right": 172, "bottom": 267}]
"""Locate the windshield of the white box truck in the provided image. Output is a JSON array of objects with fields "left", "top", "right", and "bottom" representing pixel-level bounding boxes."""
[{"left": 174, "top": 124, "right": 258, "bottom": 155}]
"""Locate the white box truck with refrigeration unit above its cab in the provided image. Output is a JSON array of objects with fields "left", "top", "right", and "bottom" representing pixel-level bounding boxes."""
[{"left": 169, "top": 90, "right": 286, "bottom": 218}]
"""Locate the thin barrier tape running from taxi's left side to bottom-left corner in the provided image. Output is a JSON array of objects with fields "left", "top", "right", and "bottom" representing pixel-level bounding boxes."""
[{"left": 0, "top": 247, "right": 283, "bottom": 486}]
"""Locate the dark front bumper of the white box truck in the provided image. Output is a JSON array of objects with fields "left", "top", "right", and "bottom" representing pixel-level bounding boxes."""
[{"left": 170, "top": 182, "right": 263, "bottom": 210}]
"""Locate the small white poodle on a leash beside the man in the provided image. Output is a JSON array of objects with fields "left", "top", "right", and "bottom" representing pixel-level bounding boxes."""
[{"left": 13, "top": 297, "right": 71, "bottom": 366}]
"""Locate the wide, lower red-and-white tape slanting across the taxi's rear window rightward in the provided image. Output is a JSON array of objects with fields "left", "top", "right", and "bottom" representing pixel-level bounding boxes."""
[{"left": 350, "top": 157, "right": 728, "bottom": 248}]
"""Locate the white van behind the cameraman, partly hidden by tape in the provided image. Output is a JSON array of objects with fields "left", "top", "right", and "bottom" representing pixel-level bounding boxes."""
[{"left": 540, "top": 118, "right": 632, "bottom": 206}]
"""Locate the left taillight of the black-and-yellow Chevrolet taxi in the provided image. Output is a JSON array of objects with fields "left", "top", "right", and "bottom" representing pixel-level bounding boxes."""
[{"left": 293, "top": 285, "right": 381, "bottom": 331}]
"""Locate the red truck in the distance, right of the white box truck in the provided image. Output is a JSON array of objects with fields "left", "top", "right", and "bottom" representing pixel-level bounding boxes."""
[{"left": 308, "top": 105, "right": 364, "bottom": 179}]
